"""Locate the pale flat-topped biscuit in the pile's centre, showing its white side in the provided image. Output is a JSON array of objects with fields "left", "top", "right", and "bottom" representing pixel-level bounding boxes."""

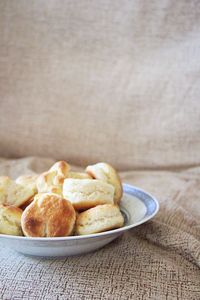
[{"left": 63, "top": 178, "right": 114, "bottom": 210}]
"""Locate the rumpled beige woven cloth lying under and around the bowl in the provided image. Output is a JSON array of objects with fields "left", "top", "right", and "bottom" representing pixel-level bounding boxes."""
[{"left": 0, "top": 157, "right": 200, "bottom": 300}]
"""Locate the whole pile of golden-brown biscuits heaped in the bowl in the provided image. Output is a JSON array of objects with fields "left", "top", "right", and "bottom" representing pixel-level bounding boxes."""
[{"left": 0, "top": 161, "right": 124, "bottom": 237}]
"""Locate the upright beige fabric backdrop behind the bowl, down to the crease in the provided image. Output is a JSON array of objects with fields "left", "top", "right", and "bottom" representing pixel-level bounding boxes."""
[{"left": 0, "top": 0, "right": 200, "bottom": 170}]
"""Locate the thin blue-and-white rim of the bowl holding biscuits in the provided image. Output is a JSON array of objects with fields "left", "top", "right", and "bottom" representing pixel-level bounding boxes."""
[{"left": 0, "top": 183, "right": 160, "bottom": 242}]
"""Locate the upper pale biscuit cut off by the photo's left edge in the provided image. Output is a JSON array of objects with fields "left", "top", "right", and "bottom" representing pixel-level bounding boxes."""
[{"left": 0, "top": 176, "right": 34, "bottom": 207}]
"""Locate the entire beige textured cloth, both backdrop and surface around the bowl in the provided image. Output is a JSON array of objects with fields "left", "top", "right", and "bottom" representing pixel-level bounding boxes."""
[{"left": 0, "top": 0, "right": 200, "bottom": 300}]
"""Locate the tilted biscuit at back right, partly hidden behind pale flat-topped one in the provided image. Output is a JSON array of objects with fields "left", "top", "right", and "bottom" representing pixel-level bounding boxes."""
[{"left": 86, "top": 162, "right": 123, "bottom": 204}]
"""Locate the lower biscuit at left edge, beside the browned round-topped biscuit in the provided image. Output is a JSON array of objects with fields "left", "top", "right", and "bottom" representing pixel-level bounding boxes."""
[{"left": 0, "top": 205, "right": 22, "bottom": 235}]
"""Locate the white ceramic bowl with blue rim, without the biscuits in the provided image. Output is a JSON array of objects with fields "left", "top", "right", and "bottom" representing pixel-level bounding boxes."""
[{"left": 0, "top": 184, "right": 159, "bottom": 257}]
